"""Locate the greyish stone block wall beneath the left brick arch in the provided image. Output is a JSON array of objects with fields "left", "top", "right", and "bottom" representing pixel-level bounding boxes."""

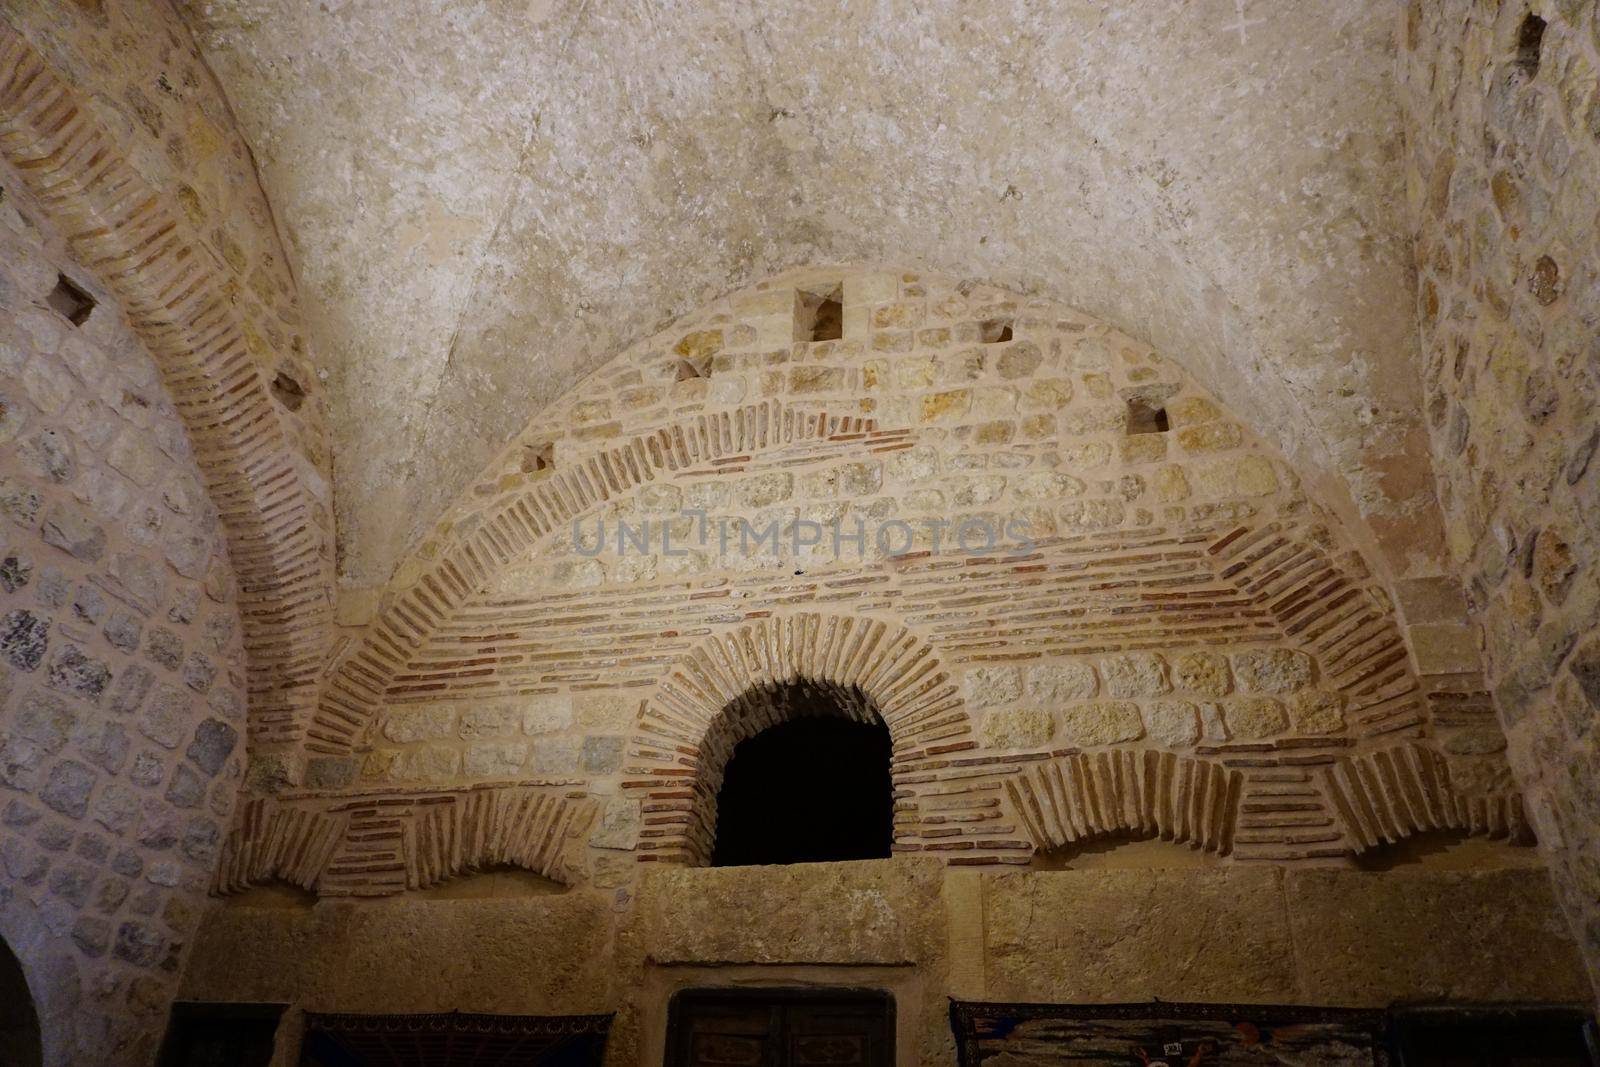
[{"left": 0, "top": 165, "right": 245, "bottom": 1065}]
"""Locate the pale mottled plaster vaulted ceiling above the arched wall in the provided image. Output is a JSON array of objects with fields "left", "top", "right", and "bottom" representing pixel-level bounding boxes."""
[{"left": 182, "top": 0, "right": 1437, "bottom": 585}]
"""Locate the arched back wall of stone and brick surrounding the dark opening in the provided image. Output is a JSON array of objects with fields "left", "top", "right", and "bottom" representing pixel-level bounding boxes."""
[{"left": 219, "top": 267, "right": 1531, "bottom": 897}]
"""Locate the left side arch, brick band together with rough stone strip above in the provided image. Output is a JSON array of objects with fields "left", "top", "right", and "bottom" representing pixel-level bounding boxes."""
[{"left": 0, "top": 0, "right": 333, "bottom": 764}]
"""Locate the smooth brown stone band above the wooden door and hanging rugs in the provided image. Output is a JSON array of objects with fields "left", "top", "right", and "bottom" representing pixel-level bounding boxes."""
[{"left": 181, "top": 863, "right": 1587, "bottom": 1067}]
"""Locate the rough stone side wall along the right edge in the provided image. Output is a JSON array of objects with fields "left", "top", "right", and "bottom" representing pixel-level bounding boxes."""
[{"left": 1402, "top": 0, "right": 1600, "bottom": 977}]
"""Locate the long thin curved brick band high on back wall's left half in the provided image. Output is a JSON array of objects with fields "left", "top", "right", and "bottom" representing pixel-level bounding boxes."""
[{"left": 307, "top": 400, "right": 906, "bottom": 755}]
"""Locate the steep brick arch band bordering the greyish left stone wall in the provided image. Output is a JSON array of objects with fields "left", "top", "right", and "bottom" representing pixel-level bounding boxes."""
[{"left": 0, "top": 22, "right": 333, "bottom": 758}]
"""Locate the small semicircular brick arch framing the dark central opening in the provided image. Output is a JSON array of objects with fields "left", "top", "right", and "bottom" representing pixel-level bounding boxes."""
[{"left": 624, "top": 611, "right": 985, "bottom": 865}]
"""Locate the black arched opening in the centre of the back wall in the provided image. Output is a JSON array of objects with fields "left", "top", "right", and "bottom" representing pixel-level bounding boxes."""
[{"left": 710, "top": 717, "right": 894, "bottom": 867}]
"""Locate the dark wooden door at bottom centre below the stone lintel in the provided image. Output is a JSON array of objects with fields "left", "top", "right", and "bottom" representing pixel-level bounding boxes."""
[{"left": 667, "top": 989, "right": 894, "bottom": 1067}]
